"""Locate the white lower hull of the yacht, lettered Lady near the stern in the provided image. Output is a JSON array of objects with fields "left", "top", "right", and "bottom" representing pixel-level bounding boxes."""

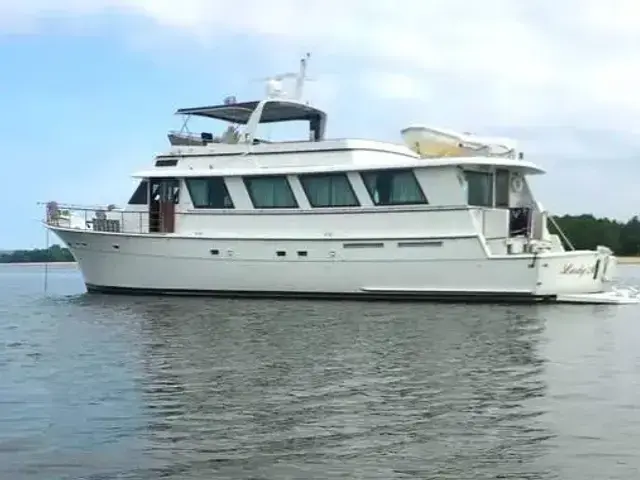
[{"left": 49, "top": 227, "right": 606, "bottom": 302}]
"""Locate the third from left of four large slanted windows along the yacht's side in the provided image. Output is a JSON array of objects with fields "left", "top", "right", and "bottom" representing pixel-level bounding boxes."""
[{"left": 299, "top": 173, "right": 360, "bottom": 208}]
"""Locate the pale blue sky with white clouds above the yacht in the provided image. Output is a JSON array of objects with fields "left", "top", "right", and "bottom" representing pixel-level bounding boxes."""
[{"left": 0, "top": 0, "right": 640, "bottom": 250}]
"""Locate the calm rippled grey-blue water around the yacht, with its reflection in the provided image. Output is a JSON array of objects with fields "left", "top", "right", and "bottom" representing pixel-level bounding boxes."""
[{"left": 0, "top": 266, "right": 640, "bottom": 480}]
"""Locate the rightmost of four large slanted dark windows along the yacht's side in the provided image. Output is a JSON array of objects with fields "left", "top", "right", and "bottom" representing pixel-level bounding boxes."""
[{"left": 361, "top": 170, "right": 428, "bottom": 205}]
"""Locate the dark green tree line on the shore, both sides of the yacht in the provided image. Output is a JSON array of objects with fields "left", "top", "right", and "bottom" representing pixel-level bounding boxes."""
[{"left": 0, "top": 214, "right": 640, "bottom": 263}]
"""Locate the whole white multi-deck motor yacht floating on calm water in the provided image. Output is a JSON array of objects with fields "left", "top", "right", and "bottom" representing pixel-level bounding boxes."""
[{"left": 45, "top": 54, "right": 636, "bottom": 303}]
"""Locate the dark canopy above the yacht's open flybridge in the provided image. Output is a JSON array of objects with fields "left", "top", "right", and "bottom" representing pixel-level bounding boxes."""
[{"left": 176, "top": 100, "right": 326, "bottom": 125}]
